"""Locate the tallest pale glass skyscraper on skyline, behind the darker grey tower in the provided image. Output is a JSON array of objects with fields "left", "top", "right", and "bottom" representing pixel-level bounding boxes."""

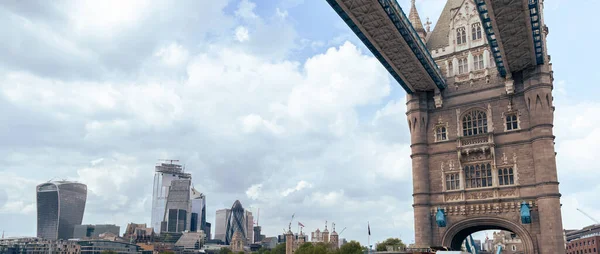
[{"left": 151, "top": 162, "right": 192, "bottom": 233}]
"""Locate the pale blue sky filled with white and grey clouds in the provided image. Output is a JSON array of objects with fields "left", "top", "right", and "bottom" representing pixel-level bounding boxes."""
[{"left": 0, "top": 0, "right": 600, "bottom": 246}]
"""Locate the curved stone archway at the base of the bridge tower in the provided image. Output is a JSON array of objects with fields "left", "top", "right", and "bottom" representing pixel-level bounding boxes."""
[{"left": 442, "top": 217, "right": 537, "bottom": 253}]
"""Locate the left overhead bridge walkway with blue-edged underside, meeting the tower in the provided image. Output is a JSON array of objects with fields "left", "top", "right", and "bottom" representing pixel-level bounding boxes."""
[{"left": 327, "top": 0, "right": 446, "bottom": 93}]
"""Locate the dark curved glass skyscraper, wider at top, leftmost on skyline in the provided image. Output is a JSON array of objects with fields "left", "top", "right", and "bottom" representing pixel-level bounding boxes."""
[{"left": 36, "top": 181, "right": 87, "bottom": 240}]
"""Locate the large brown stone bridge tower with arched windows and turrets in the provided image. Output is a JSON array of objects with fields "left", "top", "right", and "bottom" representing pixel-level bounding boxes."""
[{"left": 406, "top": 0, "right": 565, "bottom": 253}]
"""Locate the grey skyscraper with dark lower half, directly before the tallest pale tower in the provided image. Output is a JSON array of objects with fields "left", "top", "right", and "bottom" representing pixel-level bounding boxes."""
[{"left": 160, "top": 179, "right": 192, "bottom": 232}]
